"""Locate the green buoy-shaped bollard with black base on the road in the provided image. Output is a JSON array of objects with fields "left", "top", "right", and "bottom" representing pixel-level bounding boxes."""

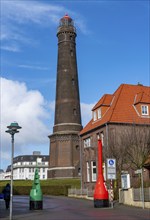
[{"left": 30, "top": 168, "right": 43, "bottom": 210}]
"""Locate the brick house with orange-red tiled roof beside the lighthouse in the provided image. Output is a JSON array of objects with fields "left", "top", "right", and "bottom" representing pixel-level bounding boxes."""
[{"left": 80, "top": 84, "right": 150, "bottom": 190}]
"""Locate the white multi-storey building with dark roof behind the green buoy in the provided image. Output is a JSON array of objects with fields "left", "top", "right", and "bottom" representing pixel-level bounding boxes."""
[{"left": 0, "top": 151, "right": 49, "bottom": 180}]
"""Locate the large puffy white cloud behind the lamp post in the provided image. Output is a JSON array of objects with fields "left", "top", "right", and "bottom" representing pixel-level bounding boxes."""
[{"left": 0, "top": 78, "right": 50, "bottom": 170}]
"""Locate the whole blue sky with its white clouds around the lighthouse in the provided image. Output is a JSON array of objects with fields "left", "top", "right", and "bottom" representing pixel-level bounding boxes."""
[{"left": 0, "top": 0, "right": 150, "bottom": 169}]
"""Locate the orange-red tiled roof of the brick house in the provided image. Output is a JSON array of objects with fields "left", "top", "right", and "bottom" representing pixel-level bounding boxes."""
[{"left": 80, "top": 84, "right": 150, "bottom": 135}]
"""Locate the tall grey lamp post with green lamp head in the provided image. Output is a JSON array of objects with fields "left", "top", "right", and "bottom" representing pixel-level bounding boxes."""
[{"left": 6, "top": 122, "right": 21, "bottom": 220}]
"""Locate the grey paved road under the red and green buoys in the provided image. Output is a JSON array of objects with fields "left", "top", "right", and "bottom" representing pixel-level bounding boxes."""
[{"left": 0, "top": 196, "right": 150, "bottom": 220}]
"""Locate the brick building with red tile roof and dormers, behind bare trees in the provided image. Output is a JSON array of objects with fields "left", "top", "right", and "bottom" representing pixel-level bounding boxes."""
[{"left": 80, "top": 84, "right": 150, "bottom": 192}]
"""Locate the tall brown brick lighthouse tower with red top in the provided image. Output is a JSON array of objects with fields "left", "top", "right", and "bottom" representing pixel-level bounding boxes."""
[{"left": 48, "top": 15, "right": 82, "bottom": 178}]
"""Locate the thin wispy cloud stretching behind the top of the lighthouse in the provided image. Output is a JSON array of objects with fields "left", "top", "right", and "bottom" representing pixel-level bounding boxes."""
[{"left": 1, "top": 0, "right": 87, "bottom": 52}]
